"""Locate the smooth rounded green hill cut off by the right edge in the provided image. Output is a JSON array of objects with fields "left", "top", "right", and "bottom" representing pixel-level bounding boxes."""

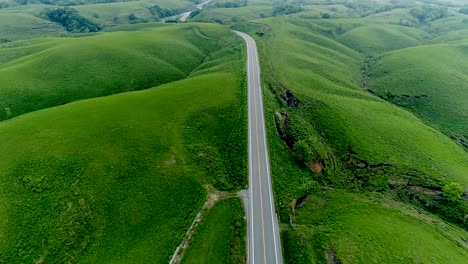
[{"left": 370, "top": 43, "right": 468, "bottom": 138}]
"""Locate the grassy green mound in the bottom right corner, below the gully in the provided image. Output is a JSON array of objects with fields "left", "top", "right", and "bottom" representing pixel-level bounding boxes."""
[{"left": 283, "top": 192, "right": 468, "bottom": 264}]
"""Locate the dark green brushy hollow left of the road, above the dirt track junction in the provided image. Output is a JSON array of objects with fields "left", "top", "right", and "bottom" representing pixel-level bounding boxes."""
[{"left": 186, "top": 102, "right": 247, "bottom": 191}]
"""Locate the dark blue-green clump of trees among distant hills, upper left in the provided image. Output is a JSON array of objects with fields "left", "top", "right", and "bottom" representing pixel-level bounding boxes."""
[{"left": 44, "top": 8, "right": 102, "bottom": 33}]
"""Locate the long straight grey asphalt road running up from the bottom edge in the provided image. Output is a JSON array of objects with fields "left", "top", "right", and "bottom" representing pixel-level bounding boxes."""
[{"left": 236, "top": 31, "right": 283, "bottom": 264}]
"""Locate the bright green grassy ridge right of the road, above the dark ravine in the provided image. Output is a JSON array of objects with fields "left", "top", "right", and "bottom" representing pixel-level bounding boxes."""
[{"left": 262, "top": 15, "right": 468, "bottom": 189}]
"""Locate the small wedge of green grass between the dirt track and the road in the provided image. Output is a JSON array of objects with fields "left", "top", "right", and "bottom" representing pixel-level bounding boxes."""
[{"left": 182, "top": 198, "right": 247, "bottom": 264}]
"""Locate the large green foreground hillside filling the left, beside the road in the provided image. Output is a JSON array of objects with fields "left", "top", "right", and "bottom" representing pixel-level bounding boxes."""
[{"left": 0, "top": 25, "right": 246, "bottom": 263}]
